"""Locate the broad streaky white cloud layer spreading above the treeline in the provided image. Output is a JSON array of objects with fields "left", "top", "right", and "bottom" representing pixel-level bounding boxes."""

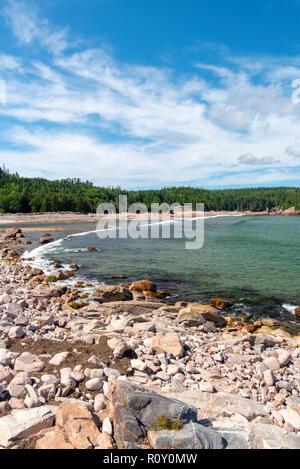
[{"left": 0, "top": 0, "right": 300, "bottom": 187}]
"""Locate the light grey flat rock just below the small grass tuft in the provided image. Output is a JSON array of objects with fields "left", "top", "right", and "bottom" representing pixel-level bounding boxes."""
[{"left": 148, "top": 422, "right": 226, "bottom": 449}]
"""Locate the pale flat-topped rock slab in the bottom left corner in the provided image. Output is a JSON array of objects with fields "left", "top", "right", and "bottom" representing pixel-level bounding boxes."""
[{"left": 0, "top": 406, "right": 57, "bottom": 448}]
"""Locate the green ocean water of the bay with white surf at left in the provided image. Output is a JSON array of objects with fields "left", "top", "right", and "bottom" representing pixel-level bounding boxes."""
[{"left": 21, "top": 216, "right": 300, "bottom": 320}]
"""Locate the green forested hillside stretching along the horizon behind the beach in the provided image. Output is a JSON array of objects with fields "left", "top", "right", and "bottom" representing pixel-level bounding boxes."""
[{"left": 0, "top": 168, "right": 300, "bottom": 213}]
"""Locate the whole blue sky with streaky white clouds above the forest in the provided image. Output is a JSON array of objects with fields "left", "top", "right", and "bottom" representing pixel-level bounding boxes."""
[{"left": 0, "top": 0, "right": 300, "bottom": 188}]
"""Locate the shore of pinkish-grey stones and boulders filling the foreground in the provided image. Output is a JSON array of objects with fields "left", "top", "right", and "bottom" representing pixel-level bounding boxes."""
[{"left": 0, "top": 229, "right": 300, "bottom": 450}]
